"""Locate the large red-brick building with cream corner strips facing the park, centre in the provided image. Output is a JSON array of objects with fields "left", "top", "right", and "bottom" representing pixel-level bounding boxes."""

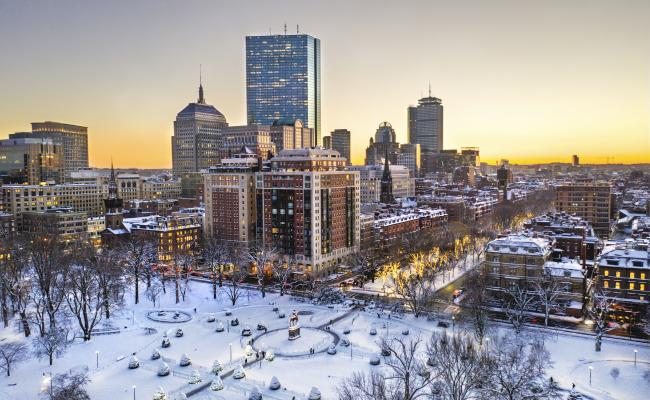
[{"left": 256, "top": 148, "right": 360, "bottom": 276}]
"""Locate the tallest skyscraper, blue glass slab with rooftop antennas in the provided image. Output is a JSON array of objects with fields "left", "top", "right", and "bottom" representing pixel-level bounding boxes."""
[{"left": 246, "top": 35, "right": 321, "bottom": 146}]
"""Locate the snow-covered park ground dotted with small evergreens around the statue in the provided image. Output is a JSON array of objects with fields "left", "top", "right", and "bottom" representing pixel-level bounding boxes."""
[{"left": 0, "top": 282, "right": 650, "bottom": 400}]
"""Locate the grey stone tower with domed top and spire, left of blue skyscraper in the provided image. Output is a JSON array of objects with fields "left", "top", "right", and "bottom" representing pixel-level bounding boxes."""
[{"left": 172, "top": 85, "right": 228, "bottom": 176}]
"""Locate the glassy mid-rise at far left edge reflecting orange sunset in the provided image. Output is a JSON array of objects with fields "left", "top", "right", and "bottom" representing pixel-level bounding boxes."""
[{"left": 0, "top": 133, "right": 64, "bottom": 185}]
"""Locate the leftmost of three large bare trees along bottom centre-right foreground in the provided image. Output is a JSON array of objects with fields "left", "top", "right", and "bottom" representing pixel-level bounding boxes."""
[{"left": 338, "top": 338, "right": 431, "bottom": 400}]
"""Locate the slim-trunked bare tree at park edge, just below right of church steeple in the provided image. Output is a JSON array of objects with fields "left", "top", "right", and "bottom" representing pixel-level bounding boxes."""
[{"left": 119, "top": 237, "right": 157, "bottom": 304}]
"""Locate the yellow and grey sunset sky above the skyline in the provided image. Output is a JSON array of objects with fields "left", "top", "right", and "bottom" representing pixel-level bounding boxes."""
[{"left": 0, "top": 0, "right": 650, "bottom": 168}]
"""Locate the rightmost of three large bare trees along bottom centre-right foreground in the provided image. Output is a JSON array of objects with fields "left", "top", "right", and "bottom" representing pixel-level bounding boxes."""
[{"left": 484, "top": 335, "right": 558, "bottom": 400}]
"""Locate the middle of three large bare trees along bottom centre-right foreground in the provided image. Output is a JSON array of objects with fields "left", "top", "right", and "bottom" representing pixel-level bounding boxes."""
[{"left": 426, "top": 333, "right": 488, "bottom": 400}]
